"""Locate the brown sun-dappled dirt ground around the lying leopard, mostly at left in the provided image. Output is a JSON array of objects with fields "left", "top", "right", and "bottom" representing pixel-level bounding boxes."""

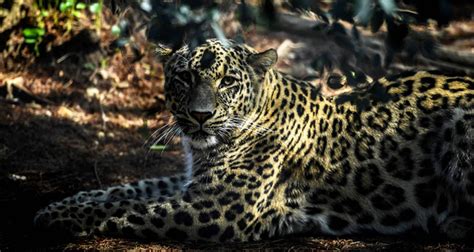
[{"left": 0, "top": 5, "right": 474, "bottom": 251}]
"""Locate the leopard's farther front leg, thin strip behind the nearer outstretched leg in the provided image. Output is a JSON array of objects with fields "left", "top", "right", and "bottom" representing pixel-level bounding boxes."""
[{"left": 63, "top": 174, "right": 189, "bottom": 204}]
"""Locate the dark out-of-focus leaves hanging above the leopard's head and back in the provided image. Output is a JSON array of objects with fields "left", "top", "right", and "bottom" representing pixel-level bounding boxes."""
[{"left": 141, "top": 0, "right": 460, "bottom": 67}]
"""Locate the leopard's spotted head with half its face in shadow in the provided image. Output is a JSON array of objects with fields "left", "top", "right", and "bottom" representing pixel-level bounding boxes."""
[{"left": 165, "top": 40, "right": 277, "bottom": 149}]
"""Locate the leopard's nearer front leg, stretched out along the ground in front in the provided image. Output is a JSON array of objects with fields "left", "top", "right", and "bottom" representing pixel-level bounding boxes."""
[{"left": 35, "top": 174, "right": 282, "bottom": 242}]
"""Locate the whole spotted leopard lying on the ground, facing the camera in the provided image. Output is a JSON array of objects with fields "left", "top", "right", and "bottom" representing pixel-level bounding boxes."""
[{"left": 34, "top": 39, "right": 474, "bottom": 243}]
